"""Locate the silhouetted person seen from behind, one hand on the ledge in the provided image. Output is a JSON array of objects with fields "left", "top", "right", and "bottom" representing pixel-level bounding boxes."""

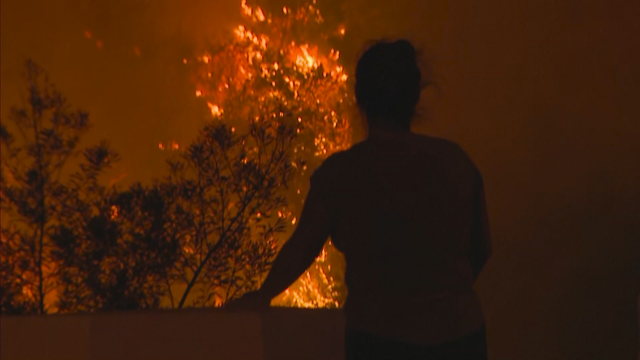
[{"left": 228, "top": 40, "right": 491, "bottom": 360}]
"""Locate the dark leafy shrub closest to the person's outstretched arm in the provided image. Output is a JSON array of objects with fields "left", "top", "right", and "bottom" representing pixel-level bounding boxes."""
[{"left": 168, "top": 117, "right": 296, "bottom": 308}]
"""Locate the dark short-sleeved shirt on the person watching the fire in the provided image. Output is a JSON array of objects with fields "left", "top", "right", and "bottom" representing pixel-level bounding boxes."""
[{"left": 310, "top": 133, "right": 491, "bottom": 344}]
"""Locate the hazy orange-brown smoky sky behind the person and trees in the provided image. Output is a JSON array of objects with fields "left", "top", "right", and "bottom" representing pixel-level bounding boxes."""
[{"left": 1, "top": 0, "right": 640, "bottom": 359}]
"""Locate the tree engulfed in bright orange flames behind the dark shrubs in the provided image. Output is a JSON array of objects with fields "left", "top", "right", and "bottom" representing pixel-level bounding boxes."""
[{"left": 184, "top": 0, "right": 351, "bottom": 307}]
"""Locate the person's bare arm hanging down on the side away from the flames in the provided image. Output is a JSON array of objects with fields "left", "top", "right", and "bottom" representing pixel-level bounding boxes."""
[{"left": 471, "top": 170, "right": 492, "bottom": 278}]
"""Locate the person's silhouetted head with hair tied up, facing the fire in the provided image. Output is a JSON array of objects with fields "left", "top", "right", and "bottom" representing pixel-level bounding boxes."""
[{"left": 355, "top": 40, "right": 421, "bottom": 131}]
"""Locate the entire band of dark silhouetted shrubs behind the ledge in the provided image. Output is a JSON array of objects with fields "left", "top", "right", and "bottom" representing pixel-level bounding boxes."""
[{"left": 0, "top": 61, "right": 296, "bottom": 314}]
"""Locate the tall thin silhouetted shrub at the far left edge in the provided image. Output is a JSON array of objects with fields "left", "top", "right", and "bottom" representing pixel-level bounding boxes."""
[{"left": 0, "top": 61, "right": 117, "bottom": 314}]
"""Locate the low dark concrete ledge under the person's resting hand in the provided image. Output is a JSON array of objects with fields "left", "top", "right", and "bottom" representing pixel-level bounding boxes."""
[{"left": 0, "top": 308, "right": 344, "bottom": 360}]
